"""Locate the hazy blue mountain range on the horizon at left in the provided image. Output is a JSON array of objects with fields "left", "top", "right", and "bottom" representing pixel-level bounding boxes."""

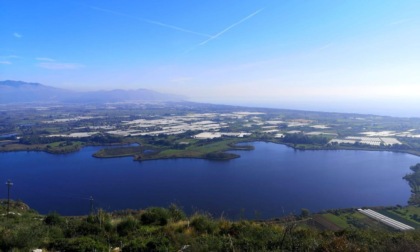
[{"left": 0, "top": 80, "right": 185, "bottom": 104}]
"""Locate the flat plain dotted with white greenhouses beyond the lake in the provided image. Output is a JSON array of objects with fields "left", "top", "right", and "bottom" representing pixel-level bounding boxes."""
[{"left": 0, "top": 102, "right": 420, "bottom": 160}]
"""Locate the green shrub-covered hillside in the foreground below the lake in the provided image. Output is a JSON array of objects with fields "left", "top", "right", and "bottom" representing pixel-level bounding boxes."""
[{"left": 0, "top": 201, "right": 420, "bottom": 251}]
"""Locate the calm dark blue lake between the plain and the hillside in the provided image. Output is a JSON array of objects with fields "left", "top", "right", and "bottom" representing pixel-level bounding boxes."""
[{"left": 0, "top": 142, "right": 420, "bottom": 218}]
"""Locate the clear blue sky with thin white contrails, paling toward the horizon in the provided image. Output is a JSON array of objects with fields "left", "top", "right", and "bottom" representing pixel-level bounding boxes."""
[{"left": 0, "top": 0, "right": 420, "bottom": 114}]
